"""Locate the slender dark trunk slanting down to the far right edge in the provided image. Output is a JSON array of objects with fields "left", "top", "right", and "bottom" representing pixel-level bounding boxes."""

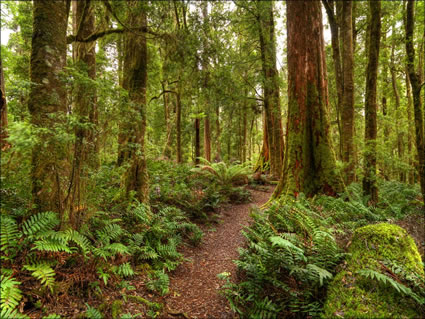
[{"left": 405, "top": 0, "right": 425, "bottom": 205}]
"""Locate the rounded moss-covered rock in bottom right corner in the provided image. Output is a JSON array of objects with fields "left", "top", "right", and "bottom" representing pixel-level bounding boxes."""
[{"left": 323, "top": 223, "right": 424, "bottom": 318}]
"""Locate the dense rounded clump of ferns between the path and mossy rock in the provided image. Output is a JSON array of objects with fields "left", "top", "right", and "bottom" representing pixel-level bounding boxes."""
[{"left": 224, "top": 196, "right": 342, "bottom": 318}]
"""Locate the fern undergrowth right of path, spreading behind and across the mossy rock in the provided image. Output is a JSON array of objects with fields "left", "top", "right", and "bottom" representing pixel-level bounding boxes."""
[{"left": 224, "top": 182, "right": 424, "bottom": 318}]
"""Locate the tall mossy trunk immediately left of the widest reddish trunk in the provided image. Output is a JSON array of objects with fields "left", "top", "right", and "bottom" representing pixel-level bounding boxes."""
[{"left": 257, "top": 1, "right": 284, "bottom": 179}]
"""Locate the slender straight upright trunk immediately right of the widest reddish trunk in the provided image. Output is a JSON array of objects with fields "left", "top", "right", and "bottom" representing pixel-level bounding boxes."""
[{"left": 341, "top": 1, "right": 355, "bottom": 184}]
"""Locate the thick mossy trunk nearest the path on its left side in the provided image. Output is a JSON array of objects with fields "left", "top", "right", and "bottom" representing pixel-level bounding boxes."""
[{"left": 119, "top": 0, "right": 149, "bottom": 203}]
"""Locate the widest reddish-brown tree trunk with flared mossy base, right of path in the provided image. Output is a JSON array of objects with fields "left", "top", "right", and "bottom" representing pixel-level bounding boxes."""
[{"left": 273, "top": 1, "right": 342, "bottom": 197}]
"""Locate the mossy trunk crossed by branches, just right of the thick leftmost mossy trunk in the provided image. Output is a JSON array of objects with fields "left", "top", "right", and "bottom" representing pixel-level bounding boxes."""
[{"left": 67, "top": 0, "right": 98, "bottom": 228}]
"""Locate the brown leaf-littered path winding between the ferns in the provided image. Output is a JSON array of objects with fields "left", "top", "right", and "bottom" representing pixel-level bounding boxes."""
[{"left": 163, "top": 187, "right": 274, "bottom": 319}]
